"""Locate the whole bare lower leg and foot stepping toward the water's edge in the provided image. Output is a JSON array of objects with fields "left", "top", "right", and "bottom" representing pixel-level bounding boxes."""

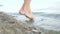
[{"left": 19, "top": 0, "right": 34, "bottom": 21}]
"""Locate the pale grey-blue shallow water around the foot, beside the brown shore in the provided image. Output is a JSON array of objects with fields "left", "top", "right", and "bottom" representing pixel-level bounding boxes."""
[{"left": 5, "top": 12, "right": 60, "bottom": 34}]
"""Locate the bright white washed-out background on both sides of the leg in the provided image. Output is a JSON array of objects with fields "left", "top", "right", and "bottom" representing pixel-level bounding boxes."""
[{"left": 0, "top": 0, "right": 60, "bottom": 14}]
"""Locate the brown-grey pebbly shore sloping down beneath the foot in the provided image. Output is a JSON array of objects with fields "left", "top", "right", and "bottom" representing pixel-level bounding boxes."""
[{"left": 0, "top": 12, "right": 41, "bottom": 34}]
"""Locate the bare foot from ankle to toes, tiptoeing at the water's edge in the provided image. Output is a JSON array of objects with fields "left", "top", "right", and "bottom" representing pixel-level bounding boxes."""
[{"left": 19, "top": 7, "right": 34, "bottom": 21}]
